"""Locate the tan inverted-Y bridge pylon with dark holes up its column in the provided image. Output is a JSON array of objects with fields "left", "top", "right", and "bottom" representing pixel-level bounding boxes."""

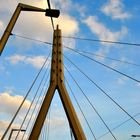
[{"left": 29, "top": 26, "right": 86, "bottom": 140}]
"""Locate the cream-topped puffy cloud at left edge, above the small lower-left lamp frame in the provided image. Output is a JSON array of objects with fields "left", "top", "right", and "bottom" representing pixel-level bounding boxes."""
[{"left": 0, "top": 92, "right": 30, "bottom": 116}]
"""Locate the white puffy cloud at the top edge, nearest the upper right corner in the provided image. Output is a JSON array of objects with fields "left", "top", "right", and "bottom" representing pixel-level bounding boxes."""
[{"left": 101, "top": 0, "right": 131, "bottom": 20}]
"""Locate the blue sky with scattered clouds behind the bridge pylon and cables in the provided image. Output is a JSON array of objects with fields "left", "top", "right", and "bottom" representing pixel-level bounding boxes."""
[{"left": 0, "top": 0, "right": 140, "bottom": 140}]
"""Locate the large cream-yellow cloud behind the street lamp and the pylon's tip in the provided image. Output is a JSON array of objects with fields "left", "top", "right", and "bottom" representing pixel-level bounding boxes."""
[{"left": 0, "top": 0, "right": 79, "bottom": 41}]
